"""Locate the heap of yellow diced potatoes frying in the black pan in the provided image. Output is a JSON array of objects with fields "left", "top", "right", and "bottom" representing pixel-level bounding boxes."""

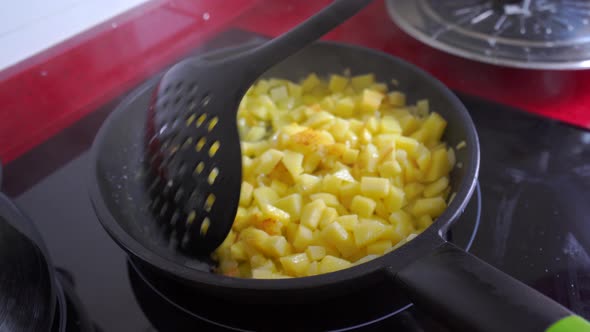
[{"left": 220, "top": 72, "right": 456, "bottom": 279}]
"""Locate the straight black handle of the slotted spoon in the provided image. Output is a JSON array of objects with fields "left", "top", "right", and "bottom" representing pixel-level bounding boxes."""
[{"left": 239, "top": 0, "right": 373, "bottom": 78}]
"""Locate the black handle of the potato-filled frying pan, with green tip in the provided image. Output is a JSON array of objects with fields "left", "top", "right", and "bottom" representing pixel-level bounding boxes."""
[{"left": 393, "top": 242, "right": 590, "bottom": 332}]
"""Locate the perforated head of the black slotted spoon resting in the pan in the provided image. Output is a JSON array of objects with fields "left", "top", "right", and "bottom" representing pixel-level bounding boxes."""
[{"left": 146, "top": 59, "right": 247, "bottom": 254}]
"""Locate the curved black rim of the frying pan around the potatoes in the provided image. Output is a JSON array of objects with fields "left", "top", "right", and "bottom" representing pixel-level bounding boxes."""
[{"left": 88, "top": 41, "right": 480, "bottom": 291}]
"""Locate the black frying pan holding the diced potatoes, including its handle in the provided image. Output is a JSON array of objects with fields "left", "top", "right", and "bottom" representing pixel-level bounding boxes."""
[{"left": 89, "top": 42, "right": 585, "bottom": 332}]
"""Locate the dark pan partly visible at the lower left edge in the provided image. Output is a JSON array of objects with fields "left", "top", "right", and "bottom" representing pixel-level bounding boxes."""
[{"left": 0, "top": 192, "right": 59, "bottom": 332}]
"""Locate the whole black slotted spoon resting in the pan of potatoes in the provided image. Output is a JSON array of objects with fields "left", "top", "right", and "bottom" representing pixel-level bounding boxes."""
[{"left": 146, "top": 0, "right": 372, "bottom": 256}]
